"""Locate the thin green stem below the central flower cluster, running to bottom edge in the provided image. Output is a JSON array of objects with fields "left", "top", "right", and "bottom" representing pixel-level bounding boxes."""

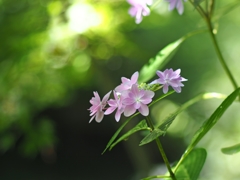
[{"left": 146, "top": 116, "right": 177, "bottom": 180}]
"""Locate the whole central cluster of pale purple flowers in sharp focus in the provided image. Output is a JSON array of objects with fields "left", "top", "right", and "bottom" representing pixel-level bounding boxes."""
[{"left": 89, "top": 69, "right": 187, "bottom": 122}]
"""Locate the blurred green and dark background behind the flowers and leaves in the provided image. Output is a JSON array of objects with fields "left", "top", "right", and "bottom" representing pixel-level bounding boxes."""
[{"left": 0, "top": 0, "right": 240, "bottom": 180}]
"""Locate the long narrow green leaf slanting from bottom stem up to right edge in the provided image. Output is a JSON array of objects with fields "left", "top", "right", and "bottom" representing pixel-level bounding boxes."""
[{"left": 176, "top": 88, "right": 240, "bottom": 172}]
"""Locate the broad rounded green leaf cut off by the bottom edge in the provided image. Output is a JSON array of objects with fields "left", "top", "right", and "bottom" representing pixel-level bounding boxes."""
[{"left": 175, "top": 148, "right": 207, "bottom": 180}]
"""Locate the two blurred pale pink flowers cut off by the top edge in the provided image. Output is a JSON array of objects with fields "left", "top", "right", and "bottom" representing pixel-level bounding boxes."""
[{"left": 127, "top": 0, "right": 186, "bottom": 24}]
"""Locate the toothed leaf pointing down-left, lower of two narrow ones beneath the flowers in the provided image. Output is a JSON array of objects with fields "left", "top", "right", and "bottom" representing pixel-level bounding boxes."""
[{"left": 109, "top": 120, "right": 151, "bottom": 150}]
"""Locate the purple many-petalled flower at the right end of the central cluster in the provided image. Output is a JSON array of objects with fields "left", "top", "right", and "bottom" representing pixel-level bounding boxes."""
[{"left": 151, "top": 69, "right": 187, "bottom": 94}]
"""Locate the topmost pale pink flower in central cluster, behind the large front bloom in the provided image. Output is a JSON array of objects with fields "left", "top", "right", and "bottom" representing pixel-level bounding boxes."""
[{"left": 115, "top": 72, "right": 139, "bottom": 93}]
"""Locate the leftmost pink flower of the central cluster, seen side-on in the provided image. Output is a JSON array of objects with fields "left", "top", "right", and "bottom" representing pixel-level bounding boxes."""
[{"left": 89, "top": 91, "right": 111, "bottom": 123}]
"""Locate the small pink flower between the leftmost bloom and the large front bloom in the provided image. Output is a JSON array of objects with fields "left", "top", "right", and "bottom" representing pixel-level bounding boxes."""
[{"left": 104, "top": 91, "right": 124, "bottom": 122}]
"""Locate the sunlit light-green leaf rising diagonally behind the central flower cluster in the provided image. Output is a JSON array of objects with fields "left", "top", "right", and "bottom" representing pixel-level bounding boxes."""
[{"left": 138, "top": 38, "right": 185, "bottom": 82}]
